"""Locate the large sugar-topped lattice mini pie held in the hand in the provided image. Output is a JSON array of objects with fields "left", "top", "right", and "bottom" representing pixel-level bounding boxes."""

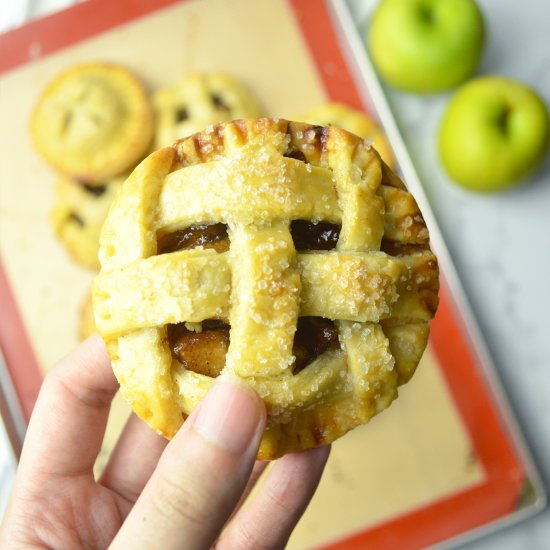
[{"left": 93, "top": 118, "right": 438, "bottom": 459}]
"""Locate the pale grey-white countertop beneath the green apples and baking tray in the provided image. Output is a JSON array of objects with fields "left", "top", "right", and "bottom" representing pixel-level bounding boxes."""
[{"left": 0, "top": 0, "right": 550, "bottom": 550}]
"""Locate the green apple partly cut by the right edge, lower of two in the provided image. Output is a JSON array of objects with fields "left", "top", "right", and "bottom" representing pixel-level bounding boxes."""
[{"left": 439, "top": 76, "right": 550, "bottom": 192}]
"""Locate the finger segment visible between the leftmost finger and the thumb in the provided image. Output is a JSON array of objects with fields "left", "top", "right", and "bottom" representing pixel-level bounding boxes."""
[{"left": 100, "top": 414, "right": 168, "bottom": 505}]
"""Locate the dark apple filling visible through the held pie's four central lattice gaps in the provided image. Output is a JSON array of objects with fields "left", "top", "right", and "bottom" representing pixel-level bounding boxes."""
[{"left": 158, "top": 220, "right": 340, "bottom": 378}]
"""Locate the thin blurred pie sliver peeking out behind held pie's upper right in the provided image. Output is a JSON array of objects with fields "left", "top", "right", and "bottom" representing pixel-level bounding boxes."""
[{"left": 296, "top": 103, "right": 395, "bottom": 168}]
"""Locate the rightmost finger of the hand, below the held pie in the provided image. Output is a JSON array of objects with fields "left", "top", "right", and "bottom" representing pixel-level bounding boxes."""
[{"left": 216, "top": 446, "right": 330, "bottom": 550}]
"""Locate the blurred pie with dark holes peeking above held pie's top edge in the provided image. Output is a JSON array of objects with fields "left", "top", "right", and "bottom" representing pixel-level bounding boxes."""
[{"left": 153, "top": 73, "right": 261, "bottom": 149}]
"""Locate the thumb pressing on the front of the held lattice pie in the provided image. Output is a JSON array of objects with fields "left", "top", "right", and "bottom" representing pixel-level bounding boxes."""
[{"left": 112, "top": 376, "right": 265, "bottom": 550}]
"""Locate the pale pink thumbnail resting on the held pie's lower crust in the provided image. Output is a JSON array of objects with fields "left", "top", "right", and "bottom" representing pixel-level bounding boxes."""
[{"left": 193, "top": 376, "right": 265, "bottom": 454}]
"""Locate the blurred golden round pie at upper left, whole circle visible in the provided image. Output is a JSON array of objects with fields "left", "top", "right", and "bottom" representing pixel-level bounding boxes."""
[{"left": 30, "top": 63, "right": 153, "bottom": 183}]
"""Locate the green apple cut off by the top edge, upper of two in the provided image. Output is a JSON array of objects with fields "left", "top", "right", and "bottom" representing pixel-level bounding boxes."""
[{"left": 366, "top": 0, "right": 485, "bottom": 93}]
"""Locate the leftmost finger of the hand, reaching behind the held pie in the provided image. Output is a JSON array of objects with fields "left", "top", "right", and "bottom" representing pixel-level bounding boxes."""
[{"left": 19, "top": 334, "right": 118, "bottom": 477}]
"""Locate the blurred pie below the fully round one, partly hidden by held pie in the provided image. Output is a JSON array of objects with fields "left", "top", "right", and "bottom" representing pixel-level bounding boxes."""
[{"left": 51, "top": 177, "right": 124, "bottom": 270}]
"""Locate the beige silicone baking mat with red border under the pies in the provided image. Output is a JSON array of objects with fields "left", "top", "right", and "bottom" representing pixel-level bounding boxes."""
[{"left": 0, "top": 0, "right": 542, "bottom": 549}]
